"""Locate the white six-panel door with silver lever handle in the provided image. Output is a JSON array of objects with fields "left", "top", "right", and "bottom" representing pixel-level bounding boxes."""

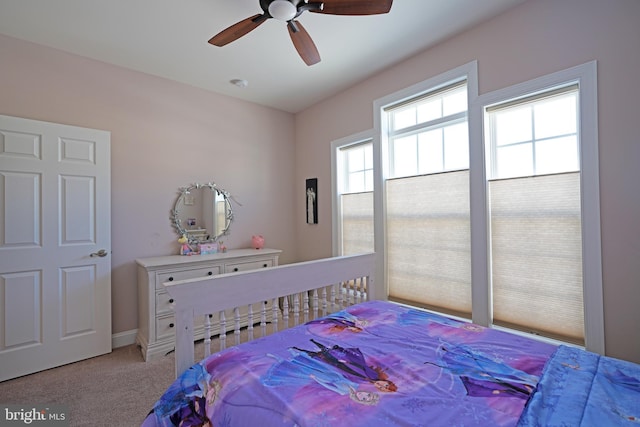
[{"left": 0, "top": 115, "right": 111, "bottom": 381}]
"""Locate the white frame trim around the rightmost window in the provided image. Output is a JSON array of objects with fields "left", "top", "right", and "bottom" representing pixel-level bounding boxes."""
[{"left": 469, "top": 61, "right": 605, "bottom": 354}]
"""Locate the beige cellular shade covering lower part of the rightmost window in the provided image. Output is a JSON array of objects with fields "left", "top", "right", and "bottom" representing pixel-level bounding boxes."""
[{"left": 489, "top": 172, "right": 584, "bottom": 344}]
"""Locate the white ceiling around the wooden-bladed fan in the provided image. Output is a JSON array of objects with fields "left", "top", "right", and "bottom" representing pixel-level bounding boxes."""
[{"left": 0, "top": 0, "right": 525, "bottom": 113}]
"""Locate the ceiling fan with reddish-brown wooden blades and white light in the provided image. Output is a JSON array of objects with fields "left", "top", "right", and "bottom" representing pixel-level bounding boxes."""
[{"left": 209, "top": 0, "right": 393, "bottom": 65}]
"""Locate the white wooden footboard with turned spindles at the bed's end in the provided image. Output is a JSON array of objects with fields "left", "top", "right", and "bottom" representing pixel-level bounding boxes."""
[{"left": 164, "top": 254, "right": 376, "bottom": 376}]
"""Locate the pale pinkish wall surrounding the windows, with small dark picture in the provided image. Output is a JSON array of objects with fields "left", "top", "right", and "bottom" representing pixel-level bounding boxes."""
[{"left": 296, "top": 0, "right": 640, "bottom": 362}]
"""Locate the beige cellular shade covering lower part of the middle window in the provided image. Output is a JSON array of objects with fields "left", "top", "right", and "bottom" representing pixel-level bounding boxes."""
[{"left": 386, "top": 170, "right": 471, "bottom": 318}]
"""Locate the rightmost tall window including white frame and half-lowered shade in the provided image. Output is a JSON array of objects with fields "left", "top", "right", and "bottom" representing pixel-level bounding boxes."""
[{"left": 470, "top": 62, "right": 604, "bottom": 353}]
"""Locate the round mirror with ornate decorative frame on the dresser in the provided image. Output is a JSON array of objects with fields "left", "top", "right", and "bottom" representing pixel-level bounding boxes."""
[{"left": 171, "top": 183, "right": 233, "bottom": 244}]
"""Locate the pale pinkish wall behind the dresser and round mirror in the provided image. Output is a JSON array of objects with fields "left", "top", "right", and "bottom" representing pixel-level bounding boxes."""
[{"left": 0, "top": 36, "right": 296, "bottom": 334}]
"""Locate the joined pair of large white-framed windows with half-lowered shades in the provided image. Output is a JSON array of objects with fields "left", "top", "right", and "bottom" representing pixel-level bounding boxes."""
[{"left": 372, "top": 62, "right": 604, "bottom": 354}]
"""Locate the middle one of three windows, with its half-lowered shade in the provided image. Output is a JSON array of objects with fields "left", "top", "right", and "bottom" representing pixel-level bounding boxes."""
[{"left": 379, "top": 64, "right": 475, "bottom": 318}]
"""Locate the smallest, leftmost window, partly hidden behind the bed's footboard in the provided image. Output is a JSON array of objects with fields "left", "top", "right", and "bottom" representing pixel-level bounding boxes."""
[{"left": 332, "top": 134, "right": 374, "bottom": 255}]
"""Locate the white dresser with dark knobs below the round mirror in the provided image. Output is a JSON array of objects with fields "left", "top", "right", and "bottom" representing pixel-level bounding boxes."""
[{"left": 136, "top": 249, "right": 282, "bottom": 361}]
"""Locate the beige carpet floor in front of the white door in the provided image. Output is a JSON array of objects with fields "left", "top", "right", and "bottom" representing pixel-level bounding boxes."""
[{"left": 0, "top": 345, "right": 211, "bottom": 427}]
